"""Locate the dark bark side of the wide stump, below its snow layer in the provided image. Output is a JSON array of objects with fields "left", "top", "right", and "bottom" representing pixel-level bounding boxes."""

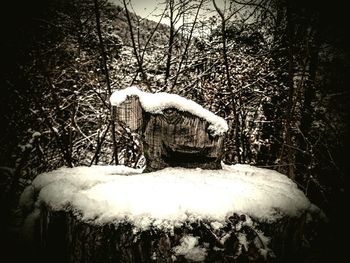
[{"left": 36, "top": 207, "right": 305, "bottom": 263}]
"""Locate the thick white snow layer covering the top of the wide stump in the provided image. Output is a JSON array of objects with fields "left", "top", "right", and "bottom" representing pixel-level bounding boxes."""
[{"left": 21, "top": 164, "right": 311, "bottom": 230}]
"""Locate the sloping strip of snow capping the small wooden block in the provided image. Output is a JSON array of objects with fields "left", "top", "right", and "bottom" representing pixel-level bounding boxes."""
[{"left": 110, "top": 86, "right": 228, "bottom": 135}]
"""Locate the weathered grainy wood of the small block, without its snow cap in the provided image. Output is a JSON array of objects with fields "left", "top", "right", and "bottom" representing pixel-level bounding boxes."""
[{"left": 115, "top": 96, "right": 224, "bottom": 172}]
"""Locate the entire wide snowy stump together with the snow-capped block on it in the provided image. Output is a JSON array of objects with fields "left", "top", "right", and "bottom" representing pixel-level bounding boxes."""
[{"left": 21, "top": 87, "right": 326, "bottom": 263}]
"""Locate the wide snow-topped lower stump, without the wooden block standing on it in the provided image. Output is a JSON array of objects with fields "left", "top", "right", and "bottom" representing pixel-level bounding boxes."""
[{"left": 21, "top": 165, "right": 322, "bottom": 262}]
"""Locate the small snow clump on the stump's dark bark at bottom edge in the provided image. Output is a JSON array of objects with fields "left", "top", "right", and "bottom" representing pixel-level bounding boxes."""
[{"left": 173, "top": 235, "right": 207, "bottom": 262}]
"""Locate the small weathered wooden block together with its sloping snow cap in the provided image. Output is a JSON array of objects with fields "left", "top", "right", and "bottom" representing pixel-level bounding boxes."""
[{"left": 111, "top": 87, "right": 227, "bottom": 171}]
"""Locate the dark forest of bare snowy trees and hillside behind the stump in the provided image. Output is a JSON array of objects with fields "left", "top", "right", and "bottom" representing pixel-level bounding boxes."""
[{"left": 0, "top": 0, "right": 350, "bottom": 262}]
